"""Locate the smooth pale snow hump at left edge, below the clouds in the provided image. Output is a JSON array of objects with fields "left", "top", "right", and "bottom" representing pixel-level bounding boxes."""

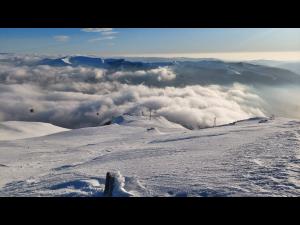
[{"left": 0, "top": 121, "right": 68, "bottom": 141}]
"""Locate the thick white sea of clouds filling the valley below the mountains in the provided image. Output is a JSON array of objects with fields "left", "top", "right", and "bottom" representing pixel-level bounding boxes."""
[{"left": 0, "top": 53, "right": 300, "bottom": 129}]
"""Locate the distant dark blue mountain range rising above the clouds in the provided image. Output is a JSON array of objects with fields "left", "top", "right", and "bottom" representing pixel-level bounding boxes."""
[{"left": 31, "top": 55, "right": 300, "bottom": 86}]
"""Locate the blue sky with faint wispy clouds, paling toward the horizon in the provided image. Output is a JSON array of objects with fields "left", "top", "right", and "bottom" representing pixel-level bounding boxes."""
[{"left": 0, "top": 28, "right": 300, "bottom": 57}]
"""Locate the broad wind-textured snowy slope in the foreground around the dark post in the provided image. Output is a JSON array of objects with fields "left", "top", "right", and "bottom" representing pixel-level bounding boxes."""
[{"left": 0, "top": 116, "right": 300, "bottom": 197}]
